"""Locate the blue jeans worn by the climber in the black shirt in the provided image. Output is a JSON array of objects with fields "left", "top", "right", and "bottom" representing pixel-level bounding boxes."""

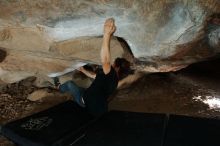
[{"left": 59, "top": 81, "right": 85, "bottom": 107}]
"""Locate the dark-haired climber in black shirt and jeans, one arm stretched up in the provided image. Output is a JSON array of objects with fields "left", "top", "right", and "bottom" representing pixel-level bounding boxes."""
[{"left": 54, "top": 18, "right": 130, "bottom": 116}]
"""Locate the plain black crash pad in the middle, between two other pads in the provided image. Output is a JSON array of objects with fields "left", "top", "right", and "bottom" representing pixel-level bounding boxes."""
[{"left": 74, "top": 111, "right": 166, "bottom": 146}]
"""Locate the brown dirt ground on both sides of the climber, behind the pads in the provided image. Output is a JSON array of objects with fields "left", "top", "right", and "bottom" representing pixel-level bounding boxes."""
[{"left": 0, "top": 60, "right": 220, "bottom": 146}]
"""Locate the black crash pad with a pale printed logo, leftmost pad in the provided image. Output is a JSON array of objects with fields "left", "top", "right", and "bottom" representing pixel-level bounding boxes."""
[{"left": 2, "top": 101, "right": 93, "bottom": 146}]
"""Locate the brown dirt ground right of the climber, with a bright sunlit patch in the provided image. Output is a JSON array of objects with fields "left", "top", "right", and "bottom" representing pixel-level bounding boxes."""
[{"left": 110, "top": 73, "right": 220, "bottom": 118}]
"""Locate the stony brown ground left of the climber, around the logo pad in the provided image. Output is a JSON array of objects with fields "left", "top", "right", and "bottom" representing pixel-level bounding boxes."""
[{"left": 0, "top": 77, "right": 70, "bottom": 146}]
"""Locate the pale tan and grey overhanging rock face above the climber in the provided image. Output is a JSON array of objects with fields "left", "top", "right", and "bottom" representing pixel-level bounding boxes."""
[{"left": 0, "top": 0, "right": 220, "bottom": 83}]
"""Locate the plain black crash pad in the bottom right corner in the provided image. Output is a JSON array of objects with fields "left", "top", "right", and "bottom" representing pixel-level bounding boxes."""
[{"left": 164, "top": 115, "right": 220, "bottom": 146}]
